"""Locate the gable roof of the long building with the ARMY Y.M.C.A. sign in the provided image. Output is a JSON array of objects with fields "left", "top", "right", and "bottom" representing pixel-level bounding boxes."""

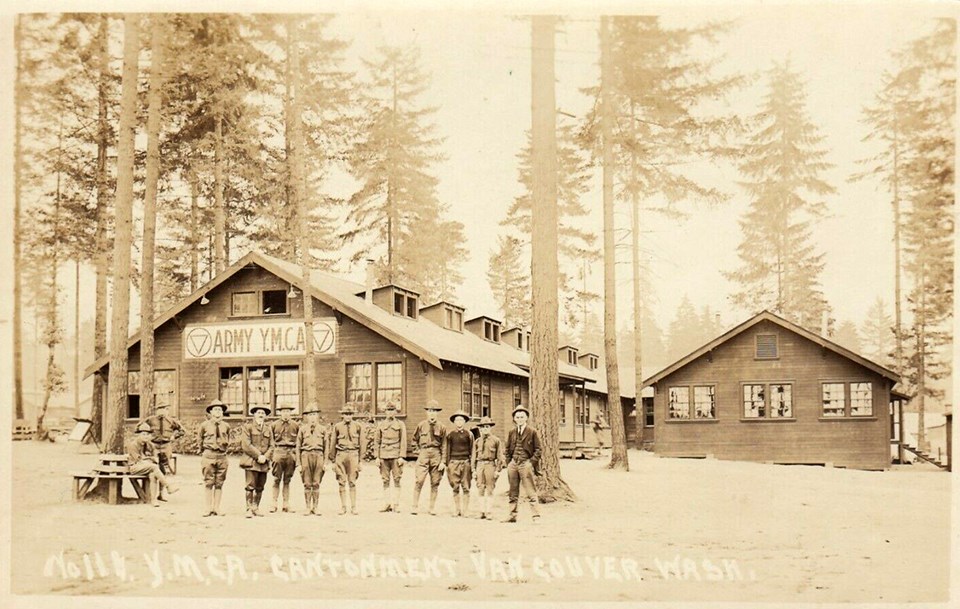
[{"left": 84, "top": 251, "right": 594, "bottom": 382}]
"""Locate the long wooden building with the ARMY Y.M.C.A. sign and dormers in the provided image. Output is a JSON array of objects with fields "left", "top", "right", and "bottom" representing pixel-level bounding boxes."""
[{"left": 87, "top": 252, "right": 605, "bottom": 448}]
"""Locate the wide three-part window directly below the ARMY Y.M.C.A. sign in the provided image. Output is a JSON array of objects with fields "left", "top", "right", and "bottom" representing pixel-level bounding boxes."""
[{"left": 219, "top": 366, "right": 300, "bottom": 415}]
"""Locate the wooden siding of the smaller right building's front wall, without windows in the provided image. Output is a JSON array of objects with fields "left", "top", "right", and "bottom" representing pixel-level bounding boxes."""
[{"left": 654, "top": 321, "right": 891, "bottom": 469}]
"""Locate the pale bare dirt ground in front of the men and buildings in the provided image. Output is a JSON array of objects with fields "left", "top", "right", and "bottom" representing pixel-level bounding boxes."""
[{"left": 5, "top": 442, "right": 950, "bottom": 603}]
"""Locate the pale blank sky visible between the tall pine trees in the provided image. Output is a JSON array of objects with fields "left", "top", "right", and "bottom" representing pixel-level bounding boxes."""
[{"left": 0, "top": 2, "right": 952, "bottom": 350}]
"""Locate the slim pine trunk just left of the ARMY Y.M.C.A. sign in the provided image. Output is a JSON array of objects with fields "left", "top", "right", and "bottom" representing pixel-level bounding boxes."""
[{"left": 140, "top": 14, "right": 166, "bottom": 414}]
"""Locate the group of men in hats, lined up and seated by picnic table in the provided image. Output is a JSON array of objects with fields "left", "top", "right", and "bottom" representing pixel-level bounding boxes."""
[{"left": 131, "top": 400, "right": 541, "bottom": 522}]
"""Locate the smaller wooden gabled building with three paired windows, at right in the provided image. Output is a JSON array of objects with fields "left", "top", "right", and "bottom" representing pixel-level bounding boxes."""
[{"left": 644, "top": 311, "right": 899, "bottom": 469}]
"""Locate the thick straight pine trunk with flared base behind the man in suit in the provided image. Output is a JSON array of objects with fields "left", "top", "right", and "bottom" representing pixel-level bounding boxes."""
[{"left": 530, "top": 15, "right": 575, "bottom": 501}]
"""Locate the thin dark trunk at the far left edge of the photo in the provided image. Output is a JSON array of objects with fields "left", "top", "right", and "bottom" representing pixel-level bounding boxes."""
[{"left": 13, "top": 15, "right": 26, "bottom": 420}]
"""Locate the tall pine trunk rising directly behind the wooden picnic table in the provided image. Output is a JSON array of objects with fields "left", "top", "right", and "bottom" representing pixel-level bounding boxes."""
[{"left": 103, "top": 13, "right": 140, "bottom": 453}]
